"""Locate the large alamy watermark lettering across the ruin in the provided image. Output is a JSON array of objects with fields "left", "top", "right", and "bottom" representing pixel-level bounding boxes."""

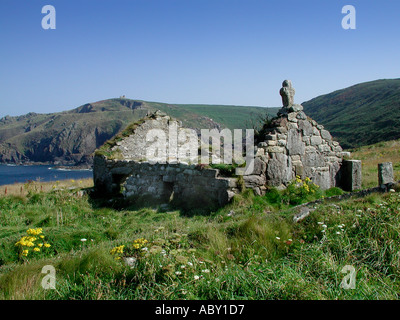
[{"left": 146, "top": 121, "right": 255, "bottom": 175}]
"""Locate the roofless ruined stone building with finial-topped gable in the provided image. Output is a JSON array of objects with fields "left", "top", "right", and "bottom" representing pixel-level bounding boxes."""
[{"left": 94, "top": 80, "right": 361, "bottom": 207}]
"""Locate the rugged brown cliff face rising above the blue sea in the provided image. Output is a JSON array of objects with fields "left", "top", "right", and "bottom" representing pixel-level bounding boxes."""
[{"left": 0, "top": 99, "right": 147, "bottom": 165}]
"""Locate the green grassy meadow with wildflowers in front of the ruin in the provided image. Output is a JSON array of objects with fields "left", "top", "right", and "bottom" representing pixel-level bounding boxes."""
[{"left": 0, "top": 182, "right": 400, "bottom": 299}]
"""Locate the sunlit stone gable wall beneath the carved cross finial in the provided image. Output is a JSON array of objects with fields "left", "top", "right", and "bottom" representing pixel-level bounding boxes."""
[{"left": 256, "top": 105, "right": 348, "bottom": 189}]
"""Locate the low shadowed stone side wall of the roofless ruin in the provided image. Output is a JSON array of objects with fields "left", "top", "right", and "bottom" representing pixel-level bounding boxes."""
[{"left": 94, "top": 156, "right": 238, "bottom": 208}]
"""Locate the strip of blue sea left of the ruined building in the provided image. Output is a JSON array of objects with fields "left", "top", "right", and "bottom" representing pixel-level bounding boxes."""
[{"left": 0, "top": 164, "right": 93, "bottom": 185}]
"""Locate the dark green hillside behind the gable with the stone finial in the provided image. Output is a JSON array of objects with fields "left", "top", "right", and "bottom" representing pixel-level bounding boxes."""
[{"left": 303, "top": 79, "right": 400, "bottom": 148}]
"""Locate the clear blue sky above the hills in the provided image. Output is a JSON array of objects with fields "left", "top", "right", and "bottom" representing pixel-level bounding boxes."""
[{"left": 0, "top": 0, "right": 400, "bottom": 117}]
